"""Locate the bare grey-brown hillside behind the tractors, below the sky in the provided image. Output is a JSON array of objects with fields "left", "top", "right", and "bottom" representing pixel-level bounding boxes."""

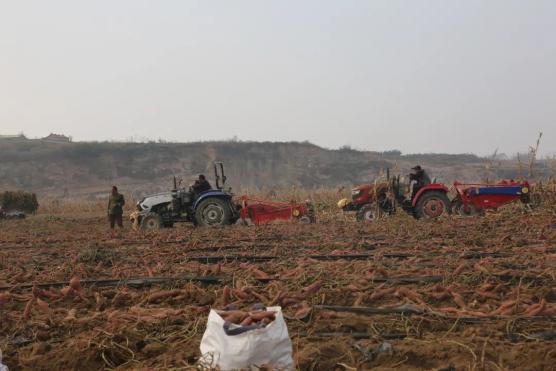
[{"left": 0, "top": 140, "right": 528, "bottom": 197}]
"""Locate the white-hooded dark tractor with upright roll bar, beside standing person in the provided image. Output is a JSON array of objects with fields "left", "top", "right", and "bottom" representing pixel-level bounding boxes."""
[{"left": 134, "top": 162, "right": 239, "bottom": 230}]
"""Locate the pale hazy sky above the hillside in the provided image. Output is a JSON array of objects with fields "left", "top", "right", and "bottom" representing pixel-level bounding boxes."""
[{"left": 0, "top": 0, "right": 556, "bottom": 154}]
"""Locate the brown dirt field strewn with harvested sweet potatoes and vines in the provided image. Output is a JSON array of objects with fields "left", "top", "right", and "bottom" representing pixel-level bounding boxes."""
[{"left": 0, "top": 198, "right": 556, "bottom": 371}]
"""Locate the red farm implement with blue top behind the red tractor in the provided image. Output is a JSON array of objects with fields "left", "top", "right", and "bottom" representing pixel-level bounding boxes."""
[{"left": 452, "top": 180, "right": 532, "bottom": 215}]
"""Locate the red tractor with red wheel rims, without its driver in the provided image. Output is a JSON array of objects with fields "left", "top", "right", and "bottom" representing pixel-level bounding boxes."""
[{"left": 338, "top": 176, "right": 452, "bottom": 220}]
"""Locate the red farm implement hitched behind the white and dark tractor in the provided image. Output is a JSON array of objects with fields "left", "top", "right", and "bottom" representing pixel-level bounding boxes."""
[{"left": 239, "top": 196, "right": 315, "bottom": 225}]
